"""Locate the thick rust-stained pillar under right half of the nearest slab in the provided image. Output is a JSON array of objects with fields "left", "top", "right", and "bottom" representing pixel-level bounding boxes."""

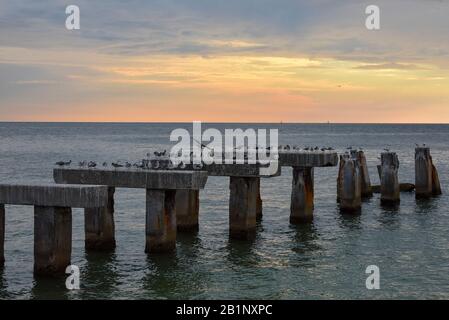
[{"left": 34, "top": 206, "right": 72, "bottom": 276}]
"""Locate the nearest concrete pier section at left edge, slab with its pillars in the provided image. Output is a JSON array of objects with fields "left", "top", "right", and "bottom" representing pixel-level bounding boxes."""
[{"left": 0, "top": 184, "right": 108, "bottom": 276}]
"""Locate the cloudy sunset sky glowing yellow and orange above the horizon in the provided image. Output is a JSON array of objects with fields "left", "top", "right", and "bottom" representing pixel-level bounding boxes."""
[{"left": 0, "top": 0, "right": 449, "bottom": 123}]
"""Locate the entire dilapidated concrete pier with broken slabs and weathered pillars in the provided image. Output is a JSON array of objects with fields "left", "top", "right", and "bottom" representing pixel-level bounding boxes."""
[{"left": 0, "top": 147, "right": 441, "bottom": 275}]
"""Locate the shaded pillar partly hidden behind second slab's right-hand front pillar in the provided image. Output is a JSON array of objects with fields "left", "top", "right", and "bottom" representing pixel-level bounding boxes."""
[{"left": 176, "top": 190, "right": 200, "bottom": 231}]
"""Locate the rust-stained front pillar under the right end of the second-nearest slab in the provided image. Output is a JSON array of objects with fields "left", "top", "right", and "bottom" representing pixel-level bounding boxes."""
[{"left": 145, "top": 189, "right": 176, "bottom": 253}]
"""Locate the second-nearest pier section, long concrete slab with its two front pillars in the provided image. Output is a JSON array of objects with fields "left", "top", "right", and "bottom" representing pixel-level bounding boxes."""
[{"left": 53, "top": 168, "right": 208, "bottom": 252}]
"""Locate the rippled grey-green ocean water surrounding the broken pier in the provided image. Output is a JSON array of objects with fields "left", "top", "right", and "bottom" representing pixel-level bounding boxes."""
[{"left": 0, "top": 123, "right": 449, "bottom": 299}]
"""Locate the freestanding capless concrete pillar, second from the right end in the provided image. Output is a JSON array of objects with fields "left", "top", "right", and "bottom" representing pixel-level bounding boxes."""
[{"left": 380, "top": 152, "right": 400, "bottom": 204}]
